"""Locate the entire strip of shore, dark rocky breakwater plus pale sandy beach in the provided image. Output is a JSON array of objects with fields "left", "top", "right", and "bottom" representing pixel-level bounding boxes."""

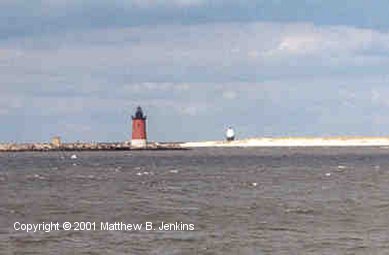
[{"left": 0, "top": 136, "right": 389, "bottom": 152}]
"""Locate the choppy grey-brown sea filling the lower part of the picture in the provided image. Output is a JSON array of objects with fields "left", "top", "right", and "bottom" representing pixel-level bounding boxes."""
[{"left": 0, "top": 147, "right": 389, "bottom": 255}]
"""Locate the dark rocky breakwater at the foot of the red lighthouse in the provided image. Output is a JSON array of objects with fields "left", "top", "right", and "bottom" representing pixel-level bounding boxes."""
[{"left": 0, "top": 142, "right": 186, "bottom": 152}]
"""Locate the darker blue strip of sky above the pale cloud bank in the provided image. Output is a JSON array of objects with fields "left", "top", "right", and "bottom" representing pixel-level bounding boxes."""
[{"left": 0, "top": 0, "right": 389, "bottom": 40}]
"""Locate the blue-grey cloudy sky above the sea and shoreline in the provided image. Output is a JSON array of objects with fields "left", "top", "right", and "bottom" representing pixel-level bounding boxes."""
[{"left": 0, "top": 0, "right": 389, "bottom": 142}]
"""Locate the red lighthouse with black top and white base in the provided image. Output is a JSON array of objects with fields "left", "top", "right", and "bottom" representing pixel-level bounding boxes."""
[{"left": 131, "top": 106, "right": 147, "bottom": 148}]
